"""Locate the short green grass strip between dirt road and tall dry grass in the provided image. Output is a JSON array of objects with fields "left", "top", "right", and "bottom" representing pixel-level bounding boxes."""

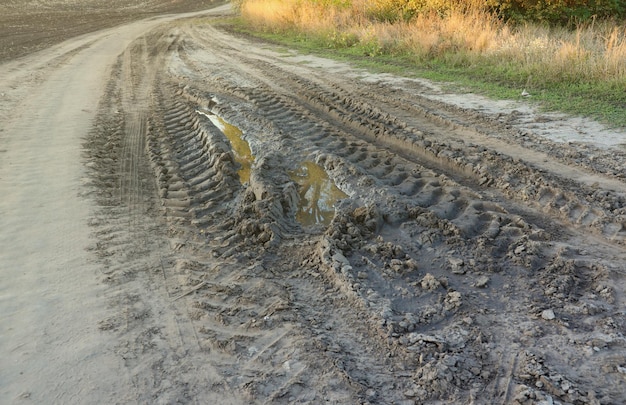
[{"left": 220, "top": 9, "right": 626, "bottom": 128}]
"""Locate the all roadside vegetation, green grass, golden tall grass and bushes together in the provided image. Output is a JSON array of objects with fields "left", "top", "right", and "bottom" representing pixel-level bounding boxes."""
[{"left": 229, "top": 0, "right": 626, "bottom": 127}]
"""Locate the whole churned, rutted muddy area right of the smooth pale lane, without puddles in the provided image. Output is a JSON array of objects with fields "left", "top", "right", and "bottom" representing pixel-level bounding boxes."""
[{"left": 87, "top": 16, "right": 626, "bottom": 404}]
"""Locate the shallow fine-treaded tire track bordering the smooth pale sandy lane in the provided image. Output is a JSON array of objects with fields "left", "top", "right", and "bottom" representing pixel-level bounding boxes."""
[{"left": 86, "top": 30, "right": 252, "bottom": 403}]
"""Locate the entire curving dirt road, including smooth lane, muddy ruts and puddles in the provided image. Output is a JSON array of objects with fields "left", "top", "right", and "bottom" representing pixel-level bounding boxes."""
[{"left": 0, "top": 1, "right": 626, "bottom": 404}]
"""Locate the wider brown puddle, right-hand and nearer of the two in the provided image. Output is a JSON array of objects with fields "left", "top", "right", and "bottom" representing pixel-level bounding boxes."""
[{"left": 290, "top": 161, "right": 348, "bottom": 225}]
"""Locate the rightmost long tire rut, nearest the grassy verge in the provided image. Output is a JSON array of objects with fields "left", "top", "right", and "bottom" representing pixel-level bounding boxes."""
[{"left": 244, "top": 57, "right": 626, "bottom": 243}]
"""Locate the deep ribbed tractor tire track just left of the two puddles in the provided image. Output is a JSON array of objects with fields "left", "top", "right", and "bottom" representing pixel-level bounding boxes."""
[{"left": 134, "top": 33, "right": 376, "bottom": 403}]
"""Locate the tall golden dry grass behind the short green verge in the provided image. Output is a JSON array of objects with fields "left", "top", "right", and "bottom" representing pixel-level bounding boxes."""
[{"left": 241, "top": 0, "right": 626, "bottom": 88}]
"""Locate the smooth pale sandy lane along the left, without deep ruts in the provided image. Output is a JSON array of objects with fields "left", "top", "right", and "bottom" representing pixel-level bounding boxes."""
[{"left": 0, "top": 4, "right": 232, "bottom": 404}]
